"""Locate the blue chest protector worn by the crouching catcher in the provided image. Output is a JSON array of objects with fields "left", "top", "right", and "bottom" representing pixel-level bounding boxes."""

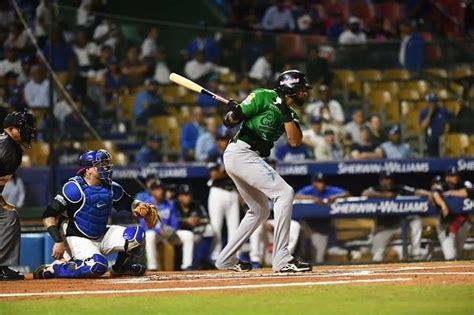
[{"left": 67, "top": 176, "right": 113, "bottom": 239}]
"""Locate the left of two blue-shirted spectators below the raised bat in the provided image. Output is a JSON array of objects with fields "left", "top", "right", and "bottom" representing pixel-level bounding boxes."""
[{"left": 179, "top": 106, "right": 204, "bottom": 161}]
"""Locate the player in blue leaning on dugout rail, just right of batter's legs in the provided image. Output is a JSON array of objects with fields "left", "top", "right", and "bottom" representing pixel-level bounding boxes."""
[{"left": 295, "top": 173, "right": 350, "bottom": 263}]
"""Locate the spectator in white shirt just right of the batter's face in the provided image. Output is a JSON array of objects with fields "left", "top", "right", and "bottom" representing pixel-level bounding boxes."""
[{"left": 306, "top": 84, "right": 344, "bottom": 124}]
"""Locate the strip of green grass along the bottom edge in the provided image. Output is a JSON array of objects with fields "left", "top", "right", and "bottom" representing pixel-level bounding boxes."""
[{"left": 0, "top": 285, "right": 474, "bottom": 315}]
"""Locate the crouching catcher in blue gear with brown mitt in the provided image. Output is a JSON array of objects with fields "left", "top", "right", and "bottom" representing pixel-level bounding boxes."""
[{"left": 33, "top": 150, "right": 159, "bottom": 279}]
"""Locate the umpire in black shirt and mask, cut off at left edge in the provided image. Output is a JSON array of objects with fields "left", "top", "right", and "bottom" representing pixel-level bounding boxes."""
[{"left": 0, "top": 111, "right": 36, "bottom": 281}]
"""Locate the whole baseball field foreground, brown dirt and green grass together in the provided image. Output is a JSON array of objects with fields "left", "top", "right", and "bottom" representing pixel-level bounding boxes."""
[{"left": 0, "top": 262, "right": 474, "bottom": 315}]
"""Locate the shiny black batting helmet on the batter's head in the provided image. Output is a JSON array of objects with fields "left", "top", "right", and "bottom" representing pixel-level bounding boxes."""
[{"left": 275, "top": 70, "right": 312, "bottom": 106}]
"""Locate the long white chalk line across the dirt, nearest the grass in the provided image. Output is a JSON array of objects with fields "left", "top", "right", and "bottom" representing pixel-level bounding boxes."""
[{"left": 0, "top": 278, "right": 411, "bottom": 298}]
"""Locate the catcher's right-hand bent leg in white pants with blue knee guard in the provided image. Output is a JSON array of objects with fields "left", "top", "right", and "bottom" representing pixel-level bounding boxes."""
[{"left": 100, "top": 225, "right": 146, "bottom": 276}]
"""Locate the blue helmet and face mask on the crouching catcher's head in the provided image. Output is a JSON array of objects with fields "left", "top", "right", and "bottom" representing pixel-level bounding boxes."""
[{"left": 77, "top": 149, "right": 113, "bottom": 183}]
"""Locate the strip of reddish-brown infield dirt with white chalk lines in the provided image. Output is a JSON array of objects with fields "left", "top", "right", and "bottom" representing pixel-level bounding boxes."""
[{"left": 0, "top": 261, "right": 474, "bottom": 300}]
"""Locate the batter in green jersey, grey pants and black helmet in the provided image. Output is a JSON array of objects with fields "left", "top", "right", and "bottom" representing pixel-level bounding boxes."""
[{"left": 216, "top": 70, "right": 312, "bottom": 272}]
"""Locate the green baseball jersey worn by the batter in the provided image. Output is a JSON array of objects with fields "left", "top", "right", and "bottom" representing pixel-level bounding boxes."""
[{"left": 236, "top": 89, "right": 300, "bottom": 157}]
